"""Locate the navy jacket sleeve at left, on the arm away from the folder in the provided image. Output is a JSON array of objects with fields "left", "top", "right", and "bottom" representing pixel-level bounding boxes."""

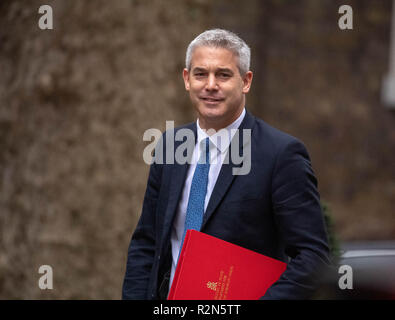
[{"left": 122, "top": 162, "right": 161, "bottom": 300}]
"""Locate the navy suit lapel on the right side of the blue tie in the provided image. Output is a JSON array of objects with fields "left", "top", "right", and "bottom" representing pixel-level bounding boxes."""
[{"left": 201, "top": 112, "right": 254, "bottom": 230}]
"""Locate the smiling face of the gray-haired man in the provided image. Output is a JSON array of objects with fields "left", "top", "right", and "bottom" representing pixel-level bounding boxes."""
[{"left": 183, "top": 46, "right": 252, "bottom": 131}]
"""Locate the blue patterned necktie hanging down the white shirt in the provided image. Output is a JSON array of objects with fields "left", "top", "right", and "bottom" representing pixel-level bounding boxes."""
[{"left": 181, "top": 138, "right": 210, "bottom": 247}]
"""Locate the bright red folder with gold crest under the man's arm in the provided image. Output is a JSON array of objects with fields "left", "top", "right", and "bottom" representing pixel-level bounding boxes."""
[{"left": 168, "top": 230, "right": 287, "bottom": 300}]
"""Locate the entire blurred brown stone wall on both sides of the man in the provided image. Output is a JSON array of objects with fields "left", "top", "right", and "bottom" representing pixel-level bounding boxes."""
[{"left": 0, "top": 0, "right": 395, "bottom": 299}]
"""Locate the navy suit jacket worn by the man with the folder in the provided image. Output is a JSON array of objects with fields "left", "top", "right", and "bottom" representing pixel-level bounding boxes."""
[{"left": 122, "top": 112, "right": 329, "bottom": 299}]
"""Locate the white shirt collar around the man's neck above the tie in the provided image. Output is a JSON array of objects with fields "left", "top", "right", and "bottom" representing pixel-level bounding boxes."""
[{"left": 196, "top": 108, "right": 246, "bottom": 153}]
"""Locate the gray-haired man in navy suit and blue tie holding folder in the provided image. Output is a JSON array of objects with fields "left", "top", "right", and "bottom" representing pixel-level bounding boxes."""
[{"left": 122, "top": 29, "right": 329, "bottom": 299}]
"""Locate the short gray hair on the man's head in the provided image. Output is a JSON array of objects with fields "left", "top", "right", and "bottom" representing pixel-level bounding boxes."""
[{"left": 185, "top": 29, "right": 251, "bottom": 75}]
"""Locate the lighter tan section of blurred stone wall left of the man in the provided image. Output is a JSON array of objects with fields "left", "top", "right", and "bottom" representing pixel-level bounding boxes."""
[{"left": 0, "top": 0, "right": 213, "bottom": 299}]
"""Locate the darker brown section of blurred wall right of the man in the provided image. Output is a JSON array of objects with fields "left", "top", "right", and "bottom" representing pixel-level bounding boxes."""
[{"left": 215, "top": 0, "right": 395, "bottom": 240}]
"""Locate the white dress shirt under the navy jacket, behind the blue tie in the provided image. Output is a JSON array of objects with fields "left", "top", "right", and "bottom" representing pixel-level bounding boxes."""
[{"left": 169, "top": 109, "right": 246, "bottom": 289}]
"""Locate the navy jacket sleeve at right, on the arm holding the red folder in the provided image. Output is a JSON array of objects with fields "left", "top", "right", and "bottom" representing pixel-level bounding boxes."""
[{"left": 261, "top": 139, "right": 330, "bottom": 299}]
